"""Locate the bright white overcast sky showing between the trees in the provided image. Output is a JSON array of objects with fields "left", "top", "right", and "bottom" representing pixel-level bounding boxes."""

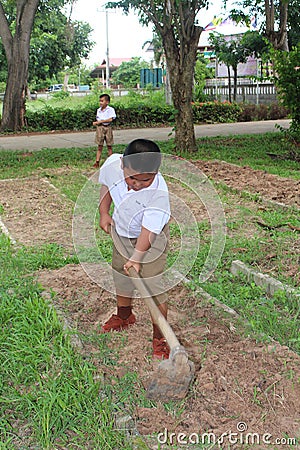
[{"left": 72, "top": 0, "right": 234, "bottom": 67}]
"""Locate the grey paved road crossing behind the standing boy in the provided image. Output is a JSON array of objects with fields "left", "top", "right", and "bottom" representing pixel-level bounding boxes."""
[{"left": 0, "top": 120, "right": 290, "bottom": 151}]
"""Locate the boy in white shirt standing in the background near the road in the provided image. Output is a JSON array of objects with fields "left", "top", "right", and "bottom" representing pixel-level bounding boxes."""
[{"left": 93, "top": 94, "right": 116, "bottom": 169}]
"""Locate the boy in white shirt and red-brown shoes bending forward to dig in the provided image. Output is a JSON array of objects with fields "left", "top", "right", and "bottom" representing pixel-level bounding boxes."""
[{"left": 99, "top": 139, "right": 170, "bottom": 359}]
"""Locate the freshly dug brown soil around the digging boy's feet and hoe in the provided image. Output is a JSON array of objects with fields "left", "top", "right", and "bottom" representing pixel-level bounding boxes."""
[{"left": 37, "top": 265, "right": 300, "bottom": 448}]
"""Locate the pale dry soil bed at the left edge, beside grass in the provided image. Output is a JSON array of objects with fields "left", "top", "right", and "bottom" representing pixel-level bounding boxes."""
[{"left": 0, "top": 179, "right": 73, "bottom": 248}]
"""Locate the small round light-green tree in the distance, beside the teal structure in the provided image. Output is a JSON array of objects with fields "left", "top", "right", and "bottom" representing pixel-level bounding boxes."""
[{"left": 112, "top": 57, "right": 150, "bottom": 88}]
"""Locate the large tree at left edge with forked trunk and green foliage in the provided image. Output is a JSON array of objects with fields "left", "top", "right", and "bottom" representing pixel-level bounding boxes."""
[{"left": 0, "top": 0, "right": 94, "bottom": 131}]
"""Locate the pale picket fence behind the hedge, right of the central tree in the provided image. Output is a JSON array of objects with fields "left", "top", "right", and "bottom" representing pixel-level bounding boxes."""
[{"left": 204, "top": 80, "right": 278, "bottom": 104}]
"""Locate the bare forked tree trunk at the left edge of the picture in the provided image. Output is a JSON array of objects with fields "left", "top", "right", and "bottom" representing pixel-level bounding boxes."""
[{"left": 0, "top": 0, "right": 40, "bottom": 131}]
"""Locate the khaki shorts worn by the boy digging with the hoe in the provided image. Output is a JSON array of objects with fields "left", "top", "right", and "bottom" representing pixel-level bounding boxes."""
[{"left": 112, "top": 225, "right": 169, "bottom": 304}]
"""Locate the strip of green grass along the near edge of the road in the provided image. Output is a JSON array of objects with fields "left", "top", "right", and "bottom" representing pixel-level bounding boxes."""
[{"left": 0, "top": 133, "right": 300, "bottom": 179}]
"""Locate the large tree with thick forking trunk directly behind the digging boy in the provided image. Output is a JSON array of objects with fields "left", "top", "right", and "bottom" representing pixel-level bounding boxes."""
[{"left": 107, "top": 0, "right": 208, "bottom": 152}]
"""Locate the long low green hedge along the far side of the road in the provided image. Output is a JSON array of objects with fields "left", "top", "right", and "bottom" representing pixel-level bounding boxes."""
[{"left": 25, "top": 92, "right": 287, "bottom": 131}]
